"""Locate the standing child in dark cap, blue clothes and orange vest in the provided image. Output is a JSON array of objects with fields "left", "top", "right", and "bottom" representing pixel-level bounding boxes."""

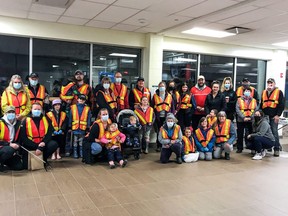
[{"left": 69, "top": 94, "right": 91, "bottom": 159}]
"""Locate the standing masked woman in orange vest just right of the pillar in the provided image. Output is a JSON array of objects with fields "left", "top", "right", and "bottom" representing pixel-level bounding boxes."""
[{"left": 151, "top": 82, "right": 175, "bottom": 152}]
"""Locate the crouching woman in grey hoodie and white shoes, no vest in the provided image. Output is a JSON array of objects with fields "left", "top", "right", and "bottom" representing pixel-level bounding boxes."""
[{"left": 247, "top": 111, "right": 275, "bottom": 160}]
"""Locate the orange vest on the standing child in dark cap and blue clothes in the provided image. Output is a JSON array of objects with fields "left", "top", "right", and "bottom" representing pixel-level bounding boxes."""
[{"left": 71, "top": 104, "right": 90, "bottom": 131}]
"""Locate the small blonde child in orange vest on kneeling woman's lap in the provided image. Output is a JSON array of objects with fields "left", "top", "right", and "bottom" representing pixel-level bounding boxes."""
[{"left": 101, "top": 123, "right": 127, "bottom": 169}]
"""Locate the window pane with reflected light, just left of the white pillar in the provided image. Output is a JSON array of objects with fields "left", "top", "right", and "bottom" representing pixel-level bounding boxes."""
[{"left": 92, "top": 45, "right": 141, "bottom": 88}]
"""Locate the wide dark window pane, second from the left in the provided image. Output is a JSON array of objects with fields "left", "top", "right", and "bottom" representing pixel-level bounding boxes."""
[{"left": 33, "top": 39, "right": 90, "bottom": 96}]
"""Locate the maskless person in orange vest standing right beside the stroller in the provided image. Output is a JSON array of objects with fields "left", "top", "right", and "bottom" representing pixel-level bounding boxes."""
[{"left": 134, "top": 96, "right": 155, "bottom": 154}]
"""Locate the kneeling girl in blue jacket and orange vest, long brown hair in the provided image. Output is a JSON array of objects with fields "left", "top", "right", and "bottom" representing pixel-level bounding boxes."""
[{"left": 194, "top": 117, "right": 216, "bottom": 161}]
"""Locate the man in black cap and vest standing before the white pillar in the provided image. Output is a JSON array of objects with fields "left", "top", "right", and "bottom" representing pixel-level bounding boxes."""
[{"left": 129, "top": 77, "right": 151, "bottom": 110}]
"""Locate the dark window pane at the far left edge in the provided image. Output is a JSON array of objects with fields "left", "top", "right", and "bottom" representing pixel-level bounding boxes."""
[{"left": 0, "top": 35, "right": 29, "bottom": 94}]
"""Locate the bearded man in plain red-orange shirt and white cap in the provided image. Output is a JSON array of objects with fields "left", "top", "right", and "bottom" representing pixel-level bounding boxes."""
[{"left": 190, "top": 75, "right": 211, "bottom": 130}]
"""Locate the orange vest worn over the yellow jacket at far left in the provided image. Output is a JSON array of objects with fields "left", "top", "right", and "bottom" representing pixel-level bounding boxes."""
[{"left": 5, "top": 90, "right": 28, "bottom": 115}]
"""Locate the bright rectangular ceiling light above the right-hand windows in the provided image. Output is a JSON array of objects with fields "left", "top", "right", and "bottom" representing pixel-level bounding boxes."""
[{"left": 182, "top": 27, "right": 236, "bottom": 38}]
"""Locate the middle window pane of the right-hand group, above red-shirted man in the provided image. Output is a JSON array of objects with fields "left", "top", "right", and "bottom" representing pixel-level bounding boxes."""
[{"left": 200, "top": 55, "right": 234, "bottom": 86}]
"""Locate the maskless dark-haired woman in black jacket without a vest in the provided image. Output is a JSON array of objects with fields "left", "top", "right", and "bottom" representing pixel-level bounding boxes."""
[{"left": 205, "top": 81, "right": 226, "bottom": 115}]
